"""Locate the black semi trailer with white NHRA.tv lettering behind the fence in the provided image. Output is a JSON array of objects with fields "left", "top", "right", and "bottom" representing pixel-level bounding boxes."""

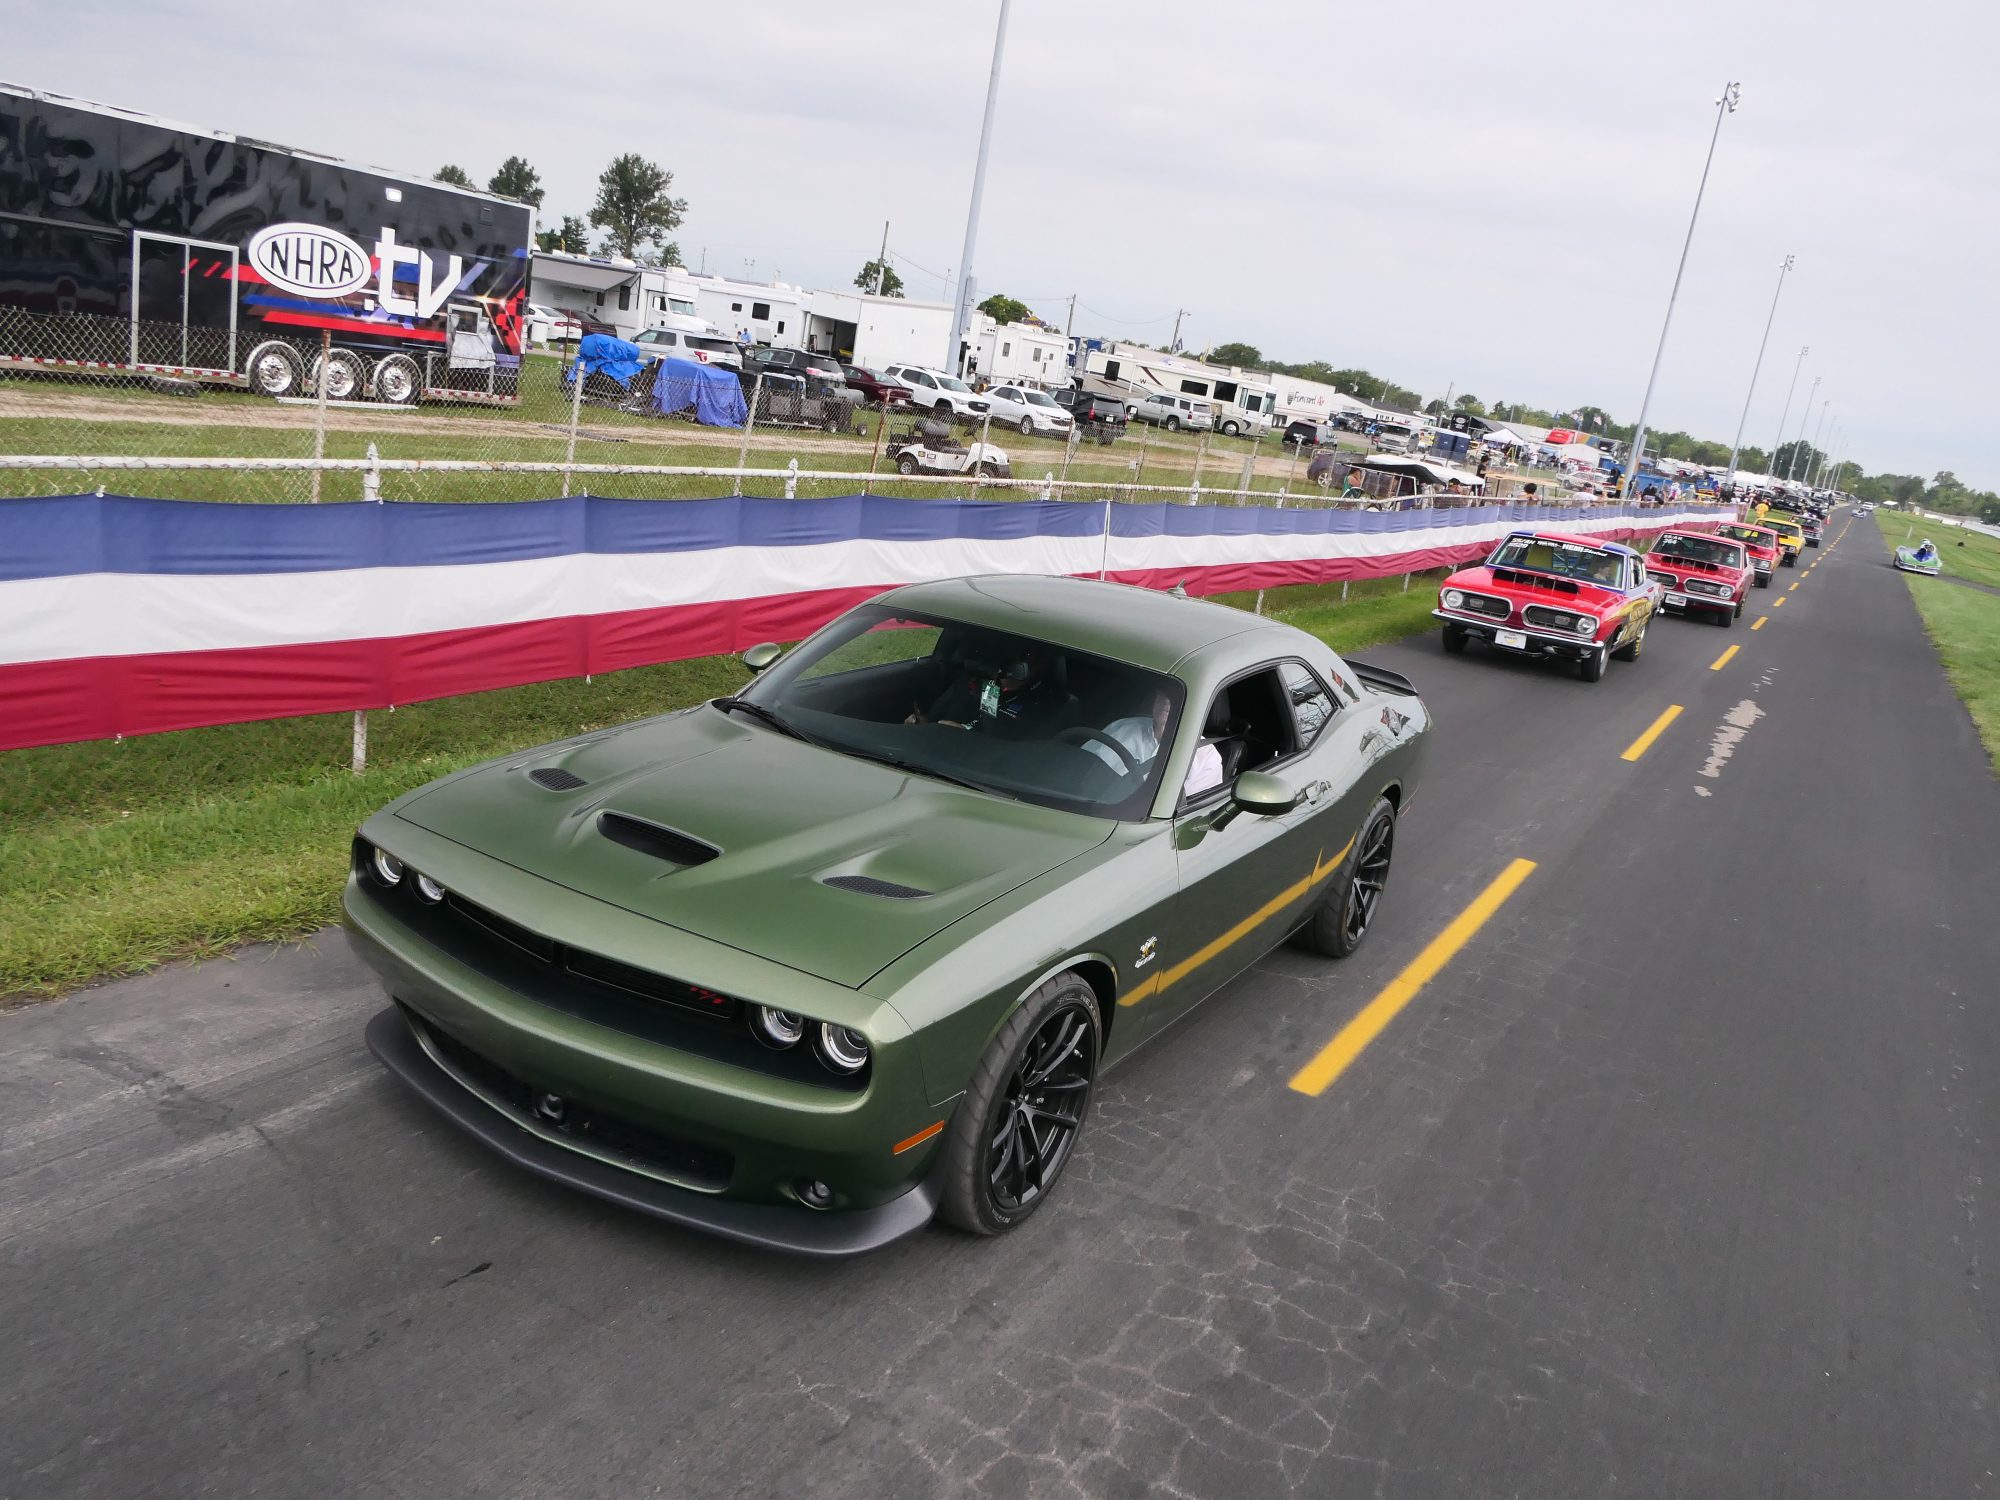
[{"left": 0, "top": 84, "right": 530, "bottom": 404}]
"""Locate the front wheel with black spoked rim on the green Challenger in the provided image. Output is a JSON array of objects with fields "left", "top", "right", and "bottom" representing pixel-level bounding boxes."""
[{"left": 938, "top": 972, "right": 1104, "bottom": 1234}]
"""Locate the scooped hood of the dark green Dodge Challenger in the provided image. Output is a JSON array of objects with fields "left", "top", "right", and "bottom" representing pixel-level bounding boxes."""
[{"left": 396, "top": 706, "right": 1114, "bottom": 988}]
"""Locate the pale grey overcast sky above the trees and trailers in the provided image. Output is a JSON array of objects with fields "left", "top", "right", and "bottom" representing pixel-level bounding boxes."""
[{"left": 0, "top": 0, "right": 2000, "bottom": 488}]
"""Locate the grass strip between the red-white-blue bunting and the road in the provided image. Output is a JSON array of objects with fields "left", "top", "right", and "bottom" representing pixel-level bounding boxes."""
[{"left": 0, "top": 574, "right": 1440, "bottom": 1004}]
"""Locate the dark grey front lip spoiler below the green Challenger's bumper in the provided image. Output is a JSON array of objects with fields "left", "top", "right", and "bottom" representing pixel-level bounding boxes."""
[{"left": 366, "top": 1006, "right": 938, "bottom": 1260}]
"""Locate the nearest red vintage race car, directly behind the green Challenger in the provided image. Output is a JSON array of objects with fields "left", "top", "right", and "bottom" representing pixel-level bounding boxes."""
[{"left": 1432, "top": 530, "right": 1662, "bottom": 682}]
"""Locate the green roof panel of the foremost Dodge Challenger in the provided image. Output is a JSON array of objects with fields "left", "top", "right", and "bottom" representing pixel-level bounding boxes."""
[{"left": 876, "top": 574, "right": 1280, "bottom": 672}]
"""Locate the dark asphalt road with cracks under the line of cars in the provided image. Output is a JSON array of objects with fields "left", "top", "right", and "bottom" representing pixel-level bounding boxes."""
[{"left": 0, "top": 522, "right": 2000, "bottom": 1500}]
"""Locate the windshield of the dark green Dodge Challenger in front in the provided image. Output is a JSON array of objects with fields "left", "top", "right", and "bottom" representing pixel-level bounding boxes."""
[{"left": 742, "top": 606, "right": 1182, "bottom": 820}]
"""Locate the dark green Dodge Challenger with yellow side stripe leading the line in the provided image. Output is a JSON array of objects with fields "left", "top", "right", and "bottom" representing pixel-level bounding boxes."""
[{"left": 346, "top": 576, "right": 1430, "bottom": 1256}]
